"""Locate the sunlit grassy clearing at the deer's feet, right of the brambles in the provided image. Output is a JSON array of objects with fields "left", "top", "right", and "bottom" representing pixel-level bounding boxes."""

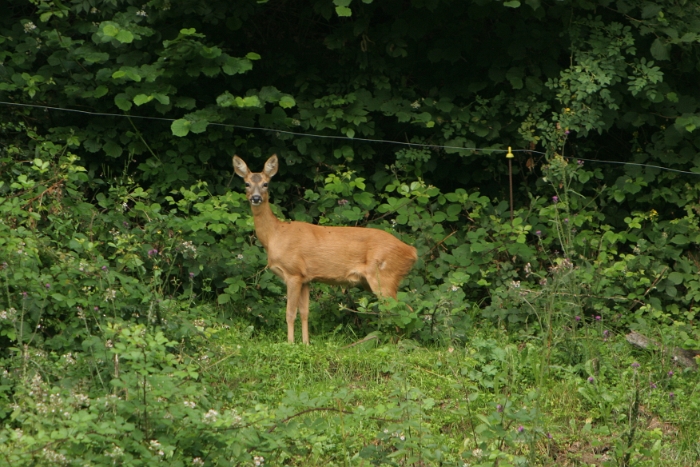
[{"left": 190, "top": 325, "right": 700, "bottom": 466}]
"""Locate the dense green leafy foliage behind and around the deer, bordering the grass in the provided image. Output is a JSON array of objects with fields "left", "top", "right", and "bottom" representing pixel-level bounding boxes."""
[{"left": 0, "top": 0, "right": 700, "bottom": 465}]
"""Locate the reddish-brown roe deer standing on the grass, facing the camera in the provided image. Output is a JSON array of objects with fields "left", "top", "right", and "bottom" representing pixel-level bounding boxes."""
[{"left": 233, "top": 155, "right": 418, "bottom": 344}]
